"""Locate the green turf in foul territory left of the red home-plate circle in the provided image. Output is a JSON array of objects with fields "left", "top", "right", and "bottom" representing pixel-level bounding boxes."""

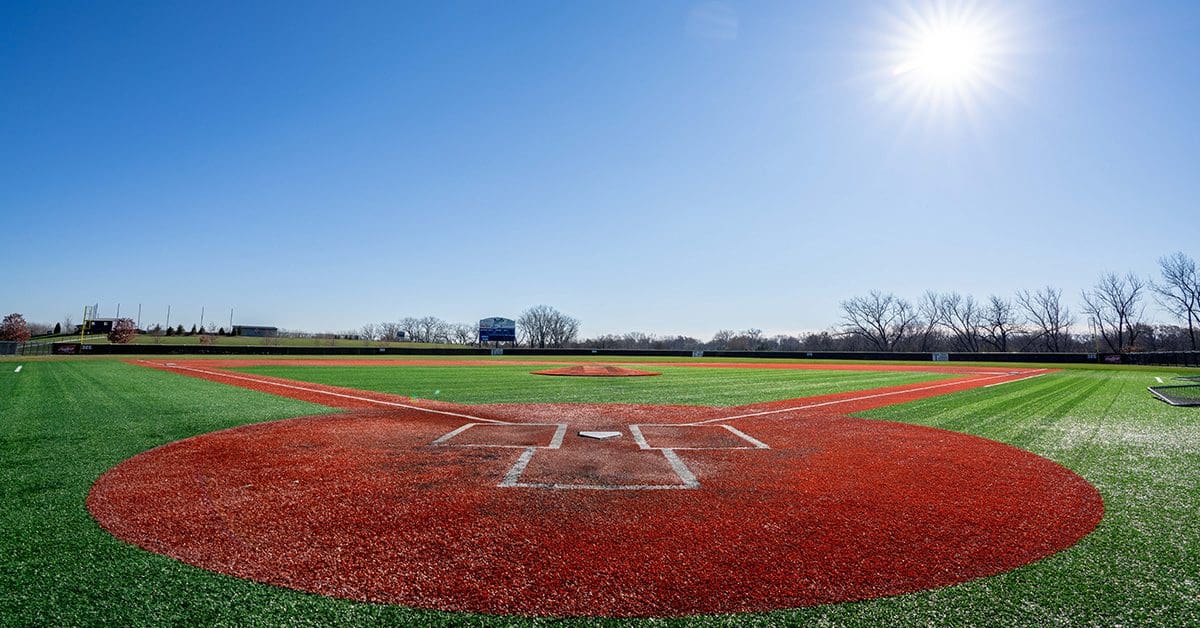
[{"left": 0, "top": 360, "right": 463, "bottom": 626}]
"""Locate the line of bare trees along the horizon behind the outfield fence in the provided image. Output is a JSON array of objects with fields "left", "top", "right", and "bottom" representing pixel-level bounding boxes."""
[{"left": 7, "top": 252, "right": 1200, "bottom": 353}]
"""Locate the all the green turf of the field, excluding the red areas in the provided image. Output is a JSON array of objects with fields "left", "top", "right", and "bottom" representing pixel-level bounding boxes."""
[{"left": 0, "top": 358, "right": 1200, "bottom": 626}]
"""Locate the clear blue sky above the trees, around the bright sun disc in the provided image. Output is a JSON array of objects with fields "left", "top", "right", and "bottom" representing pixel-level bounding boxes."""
[{"left": 0, "top": 0, "right": 1200, "bottom": 339}]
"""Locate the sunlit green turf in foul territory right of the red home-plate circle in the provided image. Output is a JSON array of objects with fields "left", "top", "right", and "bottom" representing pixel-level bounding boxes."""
[{"left": 840, "top": 371, "right": 1200, "bottom": 626}]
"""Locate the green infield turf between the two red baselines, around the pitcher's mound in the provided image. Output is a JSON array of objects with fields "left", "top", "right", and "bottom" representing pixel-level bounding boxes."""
[{"left": 234, "top": 365, "right": 961, "bottom": 406}]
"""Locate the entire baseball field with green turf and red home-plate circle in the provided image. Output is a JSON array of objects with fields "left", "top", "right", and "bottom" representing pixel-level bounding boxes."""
[{"left": 0, "top": 358, "right": 1200, "bottom": 626}]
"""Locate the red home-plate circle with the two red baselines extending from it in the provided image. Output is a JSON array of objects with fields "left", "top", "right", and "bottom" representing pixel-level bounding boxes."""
[{"left": 88, "top": 360, "right": 1103, "bottom": 616}]
